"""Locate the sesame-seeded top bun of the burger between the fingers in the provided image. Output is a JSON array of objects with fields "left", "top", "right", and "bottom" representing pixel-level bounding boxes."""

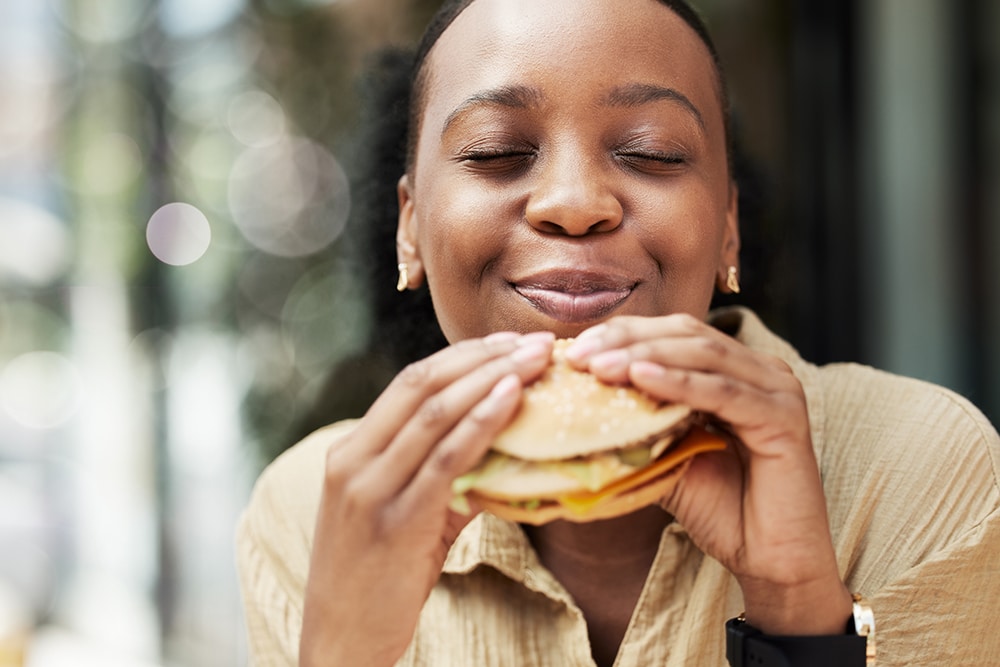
[{"left": 493, "top": 339, "right": 692, "bottom": 461}]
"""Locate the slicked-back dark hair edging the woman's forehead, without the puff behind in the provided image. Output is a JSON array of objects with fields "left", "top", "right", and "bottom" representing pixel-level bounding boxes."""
[{"left": 406, "top": 0, "right": 732, "bottom": 175}]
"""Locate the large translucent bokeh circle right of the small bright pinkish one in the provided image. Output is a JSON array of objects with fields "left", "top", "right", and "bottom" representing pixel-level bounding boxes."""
[{"left": 229, "top": 137, "right": 351, "bottom": 257}]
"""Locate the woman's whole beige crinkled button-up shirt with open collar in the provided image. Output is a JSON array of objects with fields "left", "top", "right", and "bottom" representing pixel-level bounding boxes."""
[{"left": 237, "top": 310, "right": 1000, "bottom": 667}]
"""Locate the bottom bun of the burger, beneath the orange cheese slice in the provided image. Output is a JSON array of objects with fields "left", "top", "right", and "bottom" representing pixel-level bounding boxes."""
[{"left": 469, "top": 458, "right": 691, "bottom": 526}]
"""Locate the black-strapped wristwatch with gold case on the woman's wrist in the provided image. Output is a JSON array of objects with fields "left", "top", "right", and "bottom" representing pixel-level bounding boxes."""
[{"left": 726, "top": 595, "right": 875, "bottom": 667}]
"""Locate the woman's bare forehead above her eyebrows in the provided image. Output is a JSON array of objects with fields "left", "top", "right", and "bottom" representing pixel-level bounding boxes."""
[{"left": 421, "top": 0, "right": 722, "bottom": 120}]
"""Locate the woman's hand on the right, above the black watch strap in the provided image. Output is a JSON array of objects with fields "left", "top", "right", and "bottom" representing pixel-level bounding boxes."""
[{"left": 567, "top": 314, "right": 851, "bottom": 634}]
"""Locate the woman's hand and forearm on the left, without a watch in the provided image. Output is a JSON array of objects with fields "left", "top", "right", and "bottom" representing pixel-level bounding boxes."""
[{"left": 299, "top": 333, "right": 553, "bottom": 667}]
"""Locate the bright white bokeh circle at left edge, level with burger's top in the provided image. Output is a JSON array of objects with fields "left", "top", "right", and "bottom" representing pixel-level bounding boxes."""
[{"left": 0, "top": 351, "right": 81, "bottom": 429}]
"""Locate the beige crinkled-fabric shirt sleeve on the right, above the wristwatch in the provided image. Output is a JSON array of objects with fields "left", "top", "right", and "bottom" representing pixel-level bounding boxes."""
[{"left": 821, "top": 368, "right": 1000, "bottom": 667}]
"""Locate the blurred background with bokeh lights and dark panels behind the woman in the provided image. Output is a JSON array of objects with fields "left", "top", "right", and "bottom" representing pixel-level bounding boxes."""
[{"left": 0, "top": 0, "right": 1000, "bottom": 667}]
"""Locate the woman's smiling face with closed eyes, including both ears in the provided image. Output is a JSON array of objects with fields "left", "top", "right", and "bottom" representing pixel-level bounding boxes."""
[{"left": 397, "top": 0, "right": 739, "bottom": 342}]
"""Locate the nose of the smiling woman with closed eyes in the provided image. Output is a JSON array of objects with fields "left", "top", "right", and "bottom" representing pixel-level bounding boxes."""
[{"left": 525, "top": 153, "right": 624, "bottom": 236}]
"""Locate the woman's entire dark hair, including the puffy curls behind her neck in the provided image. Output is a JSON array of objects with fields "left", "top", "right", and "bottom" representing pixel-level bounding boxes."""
[{"left": 300, "top": 0, "right": 765, "bottom": 436}]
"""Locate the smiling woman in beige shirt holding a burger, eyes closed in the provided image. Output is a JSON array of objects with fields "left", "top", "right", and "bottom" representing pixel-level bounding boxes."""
[{"left": 239, "top": 0, "right": 1000, "bottom": 665}]
